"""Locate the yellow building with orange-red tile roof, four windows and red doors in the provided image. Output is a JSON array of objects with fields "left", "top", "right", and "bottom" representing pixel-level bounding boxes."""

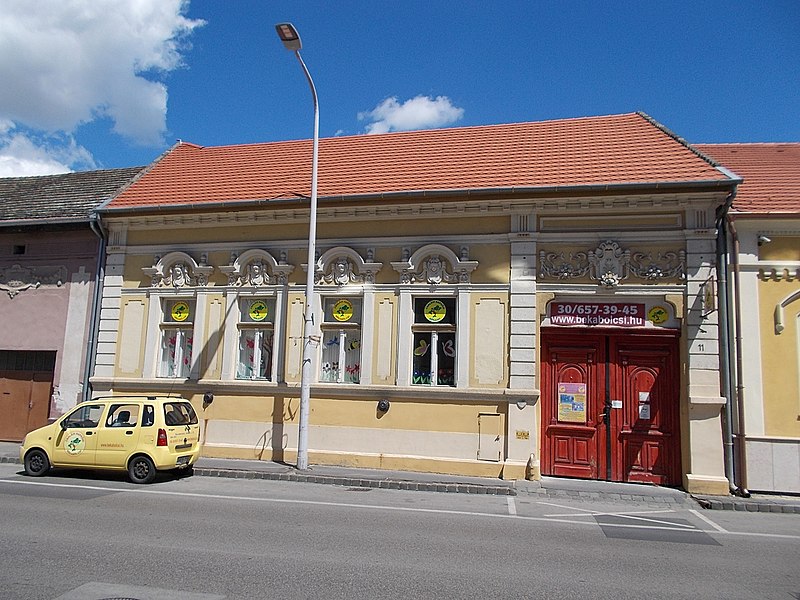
[{"left": 92, "top": 113, "right": 739, "bottom": 494}]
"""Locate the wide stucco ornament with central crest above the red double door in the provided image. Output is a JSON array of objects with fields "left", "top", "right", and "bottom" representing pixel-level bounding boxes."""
[{"left": 539, "top": 240, "right": 686, "bottom": 289}]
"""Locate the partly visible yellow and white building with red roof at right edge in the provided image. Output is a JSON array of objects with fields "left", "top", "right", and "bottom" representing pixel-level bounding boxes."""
[{"left": 698, "top": 143, "right": 800, "bottom": 493}]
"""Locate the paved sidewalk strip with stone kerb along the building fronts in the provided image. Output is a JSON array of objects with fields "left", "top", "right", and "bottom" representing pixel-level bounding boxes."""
[{"left": 0, "top": 442, "right": 800, "bottom": 514}]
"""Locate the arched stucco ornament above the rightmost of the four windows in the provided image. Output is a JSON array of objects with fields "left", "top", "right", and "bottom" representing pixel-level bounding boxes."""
[{"left": 392, "top": 244, "right": 478, "bottom": 285}]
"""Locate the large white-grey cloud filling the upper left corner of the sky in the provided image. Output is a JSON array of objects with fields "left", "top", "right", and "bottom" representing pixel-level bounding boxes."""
[{"left": 0, "top": 0, "right": 204, "bottom": 176}]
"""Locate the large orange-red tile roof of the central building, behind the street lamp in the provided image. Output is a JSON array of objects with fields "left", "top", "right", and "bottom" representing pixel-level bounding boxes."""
[{"left": 107, "top": 113, "right": 732, "bottom": 210}]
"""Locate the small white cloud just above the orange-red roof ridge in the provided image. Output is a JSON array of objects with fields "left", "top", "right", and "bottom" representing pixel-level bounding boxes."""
[{"left": 358, "top": 96, "right": 464, "bottom": 133}]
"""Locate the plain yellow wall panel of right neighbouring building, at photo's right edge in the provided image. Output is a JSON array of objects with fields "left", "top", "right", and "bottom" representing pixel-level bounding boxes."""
[{"left": 756, "top": 279, "right": 800, "bottom": 437}]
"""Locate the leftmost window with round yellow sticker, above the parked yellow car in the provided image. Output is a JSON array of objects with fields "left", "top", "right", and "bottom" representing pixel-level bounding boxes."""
[{"left": 159, "top": 299, "right": 195, "bottom": 377}]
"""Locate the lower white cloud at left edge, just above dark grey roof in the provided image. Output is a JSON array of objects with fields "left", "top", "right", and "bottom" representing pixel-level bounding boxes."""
[{"left": 0, "top": 119, "right": 97, "bottom": 177}]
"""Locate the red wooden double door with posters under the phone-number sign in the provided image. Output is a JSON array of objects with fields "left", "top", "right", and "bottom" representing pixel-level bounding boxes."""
[{"left": 541, "top": 329, "right": 681, "bottom": 485}]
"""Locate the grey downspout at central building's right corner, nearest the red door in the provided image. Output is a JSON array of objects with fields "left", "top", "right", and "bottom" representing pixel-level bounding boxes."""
[{"left": 716, "top": 188, "right": 736, "bottom": 494}]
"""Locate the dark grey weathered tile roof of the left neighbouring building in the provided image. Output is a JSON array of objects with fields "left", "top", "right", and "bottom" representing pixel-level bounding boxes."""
[{"left": 0, "top": 167, "right": 144, "bottom": 226}]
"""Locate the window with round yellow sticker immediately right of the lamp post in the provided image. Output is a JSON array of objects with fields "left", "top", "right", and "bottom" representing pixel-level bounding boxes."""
[{"left": 319, "top": 296, "right": 361, "bottom": 383}]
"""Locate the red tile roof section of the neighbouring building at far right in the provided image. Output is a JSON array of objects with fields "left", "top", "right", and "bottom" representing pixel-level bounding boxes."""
[{"left": 694, "top": 143, "right": 800, "bottom": 214}]
